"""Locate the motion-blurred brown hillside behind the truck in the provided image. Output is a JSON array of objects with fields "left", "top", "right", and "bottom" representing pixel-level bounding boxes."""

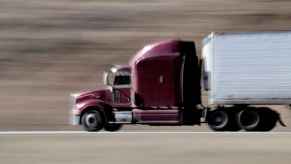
[{"left": 0, "top": 0, "right": 291, "bottom": 130}]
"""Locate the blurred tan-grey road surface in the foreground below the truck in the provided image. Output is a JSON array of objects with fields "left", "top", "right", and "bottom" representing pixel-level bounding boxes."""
[{"left": 0, "top": 131, "right": 291, "bottom": 164}]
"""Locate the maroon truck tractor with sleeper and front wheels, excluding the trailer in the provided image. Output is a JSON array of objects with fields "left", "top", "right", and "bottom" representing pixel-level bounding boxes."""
[{"left": 72, "top": 40, "right": 201, "bottom": 131}]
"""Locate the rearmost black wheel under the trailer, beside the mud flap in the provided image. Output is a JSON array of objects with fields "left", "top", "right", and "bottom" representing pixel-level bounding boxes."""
[{"left": 238, "top": 108, "right": 279, "bottom": 132}]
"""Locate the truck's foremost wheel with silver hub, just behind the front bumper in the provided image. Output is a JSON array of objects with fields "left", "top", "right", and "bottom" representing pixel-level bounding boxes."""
[{"left": 81, "top": 110, "right": 104, "bottom": 132}]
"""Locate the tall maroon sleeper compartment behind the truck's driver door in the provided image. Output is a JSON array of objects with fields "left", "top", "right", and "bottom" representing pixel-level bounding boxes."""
[{"left": 130, "top": 40, "right": 200, "bottom": 107}]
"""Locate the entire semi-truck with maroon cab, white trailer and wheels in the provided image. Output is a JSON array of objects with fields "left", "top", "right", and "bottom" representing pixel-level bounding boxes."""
[{"left": 70, "top": 31, "right": 291, "bottom": 132}]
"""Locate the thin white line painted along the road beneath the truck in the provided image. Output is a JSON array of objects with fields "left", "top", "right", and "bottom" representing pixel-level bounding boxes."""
[{"left": 0, "top": 131, "right": 291, "bottom": 135}]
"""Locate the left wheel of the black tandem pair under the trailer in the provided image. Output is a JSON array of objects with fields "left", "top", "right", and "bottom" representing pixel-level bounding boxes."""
[{"left": 207, "top": 108, "right": 241, "bottom": 131}]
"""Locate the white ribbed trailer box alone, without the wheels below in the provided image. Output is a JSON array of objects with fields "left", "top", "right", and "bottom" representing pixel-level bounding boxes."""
[{"left": 202, "top": 32, "right": 291, "bottom": 105}]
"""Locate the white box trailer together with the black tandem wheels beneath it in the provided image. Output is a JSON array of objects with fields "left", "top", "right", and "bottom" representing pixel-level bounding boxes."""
[{"left": 202, "top": 32, "right": 291, "bottom": 131}]
